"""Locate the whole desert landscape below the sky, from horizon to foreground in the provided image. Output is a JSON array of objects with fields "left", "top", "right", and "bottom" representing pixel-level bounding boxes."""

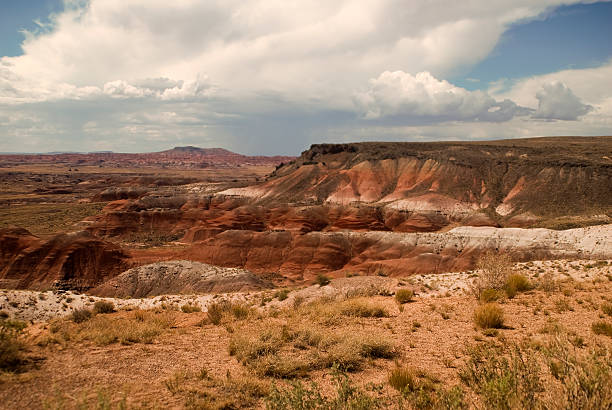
[{"left": 0, "top": 137, "right": 612, "bottom": 409}]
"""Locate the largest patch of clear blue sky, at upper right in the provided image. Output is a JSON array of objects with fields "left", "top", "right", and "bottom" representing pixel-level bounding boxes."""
[{"left": 452, "top": 2, "right": 612, "bottom": 89}]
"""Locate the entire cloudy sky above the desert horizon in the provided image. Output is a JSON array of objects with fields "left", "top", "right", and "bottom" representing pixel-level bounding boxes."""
[{"left": 0, "top": 0, "right": 612, "bottom": 155}]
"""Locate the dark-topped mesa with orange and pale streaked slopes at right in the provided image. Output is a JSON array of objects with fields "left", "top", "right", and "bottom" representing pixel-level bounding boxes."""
[{"left": 226, "top": 137, "right": 612, "bottom": 221}]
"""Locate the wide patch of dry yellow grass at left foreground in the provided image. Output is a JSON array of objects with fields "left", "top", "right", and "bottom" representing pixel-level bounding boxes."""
[{"left": 50, "top": 310, "right": 174, "bottom": 345}]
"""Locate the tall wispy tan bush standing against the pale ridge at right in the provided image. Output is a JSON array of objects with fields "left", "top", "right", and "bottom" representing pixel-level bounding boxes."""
[{"left": 472, "top": 252, "right": 512, "bottom": 299}]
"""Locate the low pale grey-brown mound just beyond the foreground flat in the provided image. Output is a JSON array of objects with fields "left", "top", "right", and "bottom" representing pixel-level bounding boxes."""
[{"left": 91, "top": 260, "right": 272, "bottom": 298}]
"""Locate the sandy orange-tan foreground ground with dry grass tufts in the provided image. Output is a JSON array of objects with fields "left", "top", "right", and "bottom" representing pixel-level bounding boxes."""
[{"left": 0, "top": 261, "right": 612, "bottom": 409}]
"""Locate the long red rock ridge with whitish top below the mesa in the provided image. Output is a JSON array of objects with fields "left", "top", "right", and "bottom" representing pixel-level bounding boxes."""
[{"left": 170, "top": 225, "right": 612, "bottom": 282}]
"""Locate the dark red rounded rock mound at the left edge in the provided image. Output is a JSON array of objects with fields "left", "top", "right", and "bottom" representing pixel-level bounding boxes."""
[{"left": 0, "top": 229, "right": 128, "bottom": 290}]
